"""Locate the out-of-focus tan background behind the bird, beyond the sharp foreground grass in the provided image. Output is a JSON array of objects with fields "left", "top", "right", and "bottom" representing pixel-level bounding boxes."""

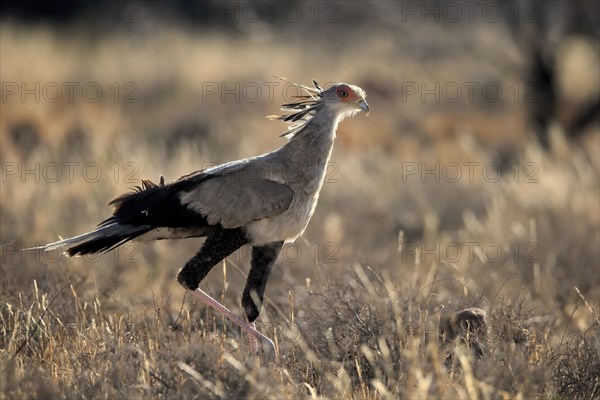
[{"left": 0, "top": 0, "right": 600, "bottom": 396}]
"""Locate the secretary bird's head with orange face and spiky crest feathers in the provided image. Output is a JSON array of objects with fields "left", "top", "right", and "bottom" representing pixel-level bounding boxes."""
[{"left": 267, "top": 78, "right": 369, "bottom": 137}]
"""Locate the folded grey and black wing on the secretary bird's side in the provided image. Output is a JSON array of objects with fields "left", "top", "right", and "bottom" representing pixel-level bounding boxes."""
[{"left": 108, "top": 162, "right": 294, "bottom": 229}]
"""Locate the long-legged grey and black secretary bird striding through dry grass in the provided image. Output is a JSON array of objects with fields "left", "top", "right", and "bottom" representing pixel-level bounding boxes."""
[{"left": 36, "top": 81, "right": 369, "bottom": 350}]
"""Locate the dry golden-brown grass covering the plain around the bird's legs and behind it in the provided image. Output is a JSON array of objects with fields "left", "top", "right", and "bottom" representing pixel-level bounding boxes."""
[{"left": 0, "top": 7, "right": 600, "bottom": 399}]
